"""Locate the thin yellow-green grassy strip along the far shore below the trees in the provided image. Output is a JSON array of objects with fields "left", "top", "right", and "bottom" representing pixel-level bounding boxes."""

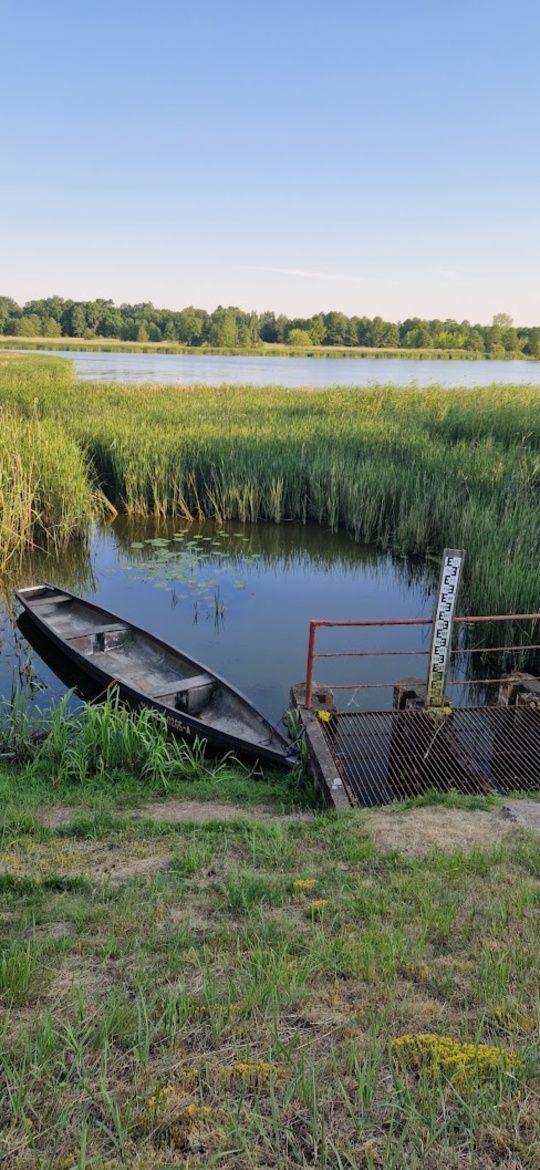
[{"left": 0, "top": 336, "right": 530, "bottom": 362}]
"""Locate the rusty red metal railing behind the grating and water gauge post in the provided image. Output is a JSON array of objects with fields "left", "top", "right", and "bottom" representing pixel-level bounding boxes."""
[{"left": 304, "top": 613, "right": 540, "bottom": 709}]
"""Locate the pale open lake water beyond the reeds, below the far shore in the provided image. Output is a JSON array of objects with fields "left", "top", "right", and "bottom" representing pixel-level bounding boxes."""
[{"left": 25, "top": 350, "right": 540, "bottom": 387}]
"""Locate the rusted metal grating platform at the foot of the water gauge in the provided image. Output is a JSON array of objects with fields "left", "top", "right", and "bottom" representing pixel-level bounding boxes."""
[{"left": 321, "top": 704, "right": 540, "bottom": 805}]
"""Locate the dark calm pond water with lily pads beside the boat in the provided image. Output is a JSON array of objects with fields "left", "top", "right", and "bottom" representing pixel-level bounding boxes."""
[{"left": 0, "top": 518, "right": 437, "bottom": 720}]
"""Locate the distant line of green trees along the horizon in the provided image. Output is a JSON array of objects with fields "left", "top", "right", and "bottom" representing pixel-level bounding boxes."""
[{"left": 0, "top": 296, "right": 540, "bottom": 358}]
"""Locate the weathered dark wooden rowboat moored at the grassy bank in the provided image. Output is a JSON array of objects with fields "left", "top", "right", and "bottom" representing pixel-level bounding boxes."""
[{"left": 16, "top": 585, "right": 295, "bottom": 768}]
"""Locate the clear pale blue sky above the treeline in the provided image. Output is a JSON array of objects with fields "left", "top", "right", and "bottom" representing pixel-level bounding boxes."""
[{"left": 0, "top": 0, "right": 540, "bottom": 324}]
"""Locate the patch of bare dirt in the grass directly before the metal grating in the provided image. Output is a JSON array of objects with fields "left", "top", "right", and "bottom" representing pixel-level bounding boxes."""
[{"left": 365, "top": 806, "right": 515, "bottom": 856}]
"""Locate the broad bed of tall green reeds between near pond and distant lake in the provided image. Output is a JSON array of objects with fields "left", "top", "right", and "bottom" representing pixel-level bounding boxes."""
[{"left": 0, "top": 355, "right": 540, "bottom": 613}]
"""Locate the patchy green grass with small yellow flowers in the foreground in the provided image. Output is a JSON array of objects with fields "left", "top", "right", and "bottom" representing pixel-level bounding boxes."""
[{"left": 0, "top": 770, "right": 540, "bottom": 1170}]
